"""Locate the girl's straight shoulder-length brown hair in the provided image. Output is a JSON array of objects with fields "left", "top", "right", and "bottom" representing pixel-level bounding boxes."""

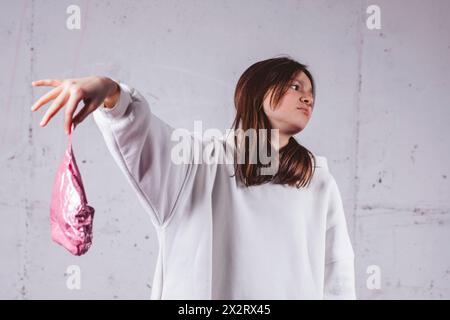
[{"left": 231, "top": 56, "right": 315, "bottom": 188}]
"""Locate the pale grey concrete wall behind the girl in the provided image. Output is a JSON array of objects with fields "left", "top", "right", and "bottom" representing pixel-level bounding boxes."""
[{"left": 0, "top": 0, "right": 450, "bottom": 299}]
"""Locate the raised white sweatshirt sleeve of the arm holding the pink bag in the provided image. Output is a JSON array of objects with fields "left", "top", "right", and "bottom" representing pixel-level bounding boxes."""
[{"left": 93, "top": 80, "right": 191, "bottom": 227}]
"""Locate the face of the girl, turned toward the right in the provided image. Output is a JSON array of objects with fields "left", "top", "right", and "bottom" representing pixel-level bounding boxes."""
[{"left": 263, "top": 72, "right": 313, "bottom": 145}]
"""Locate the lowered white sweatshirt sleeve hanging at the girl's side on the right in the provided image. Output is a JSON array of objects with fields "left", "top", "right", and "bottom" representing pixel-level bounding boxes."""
[{"left": 324, "top": 177, "right": 356, "bottom": 300}]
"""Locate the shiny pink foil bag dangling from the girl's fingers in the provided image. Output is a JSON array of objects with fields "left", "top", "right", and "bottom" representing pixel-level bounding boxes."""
[{"left": 50, "top": 125, "right": 95, "bottom": 256}]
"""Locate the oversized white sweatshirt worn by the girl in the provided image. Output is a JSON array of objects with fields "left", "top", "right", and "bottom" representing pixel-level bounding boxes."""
[{"left": 93, "top": 81, "right": 356, "bottom": 299}]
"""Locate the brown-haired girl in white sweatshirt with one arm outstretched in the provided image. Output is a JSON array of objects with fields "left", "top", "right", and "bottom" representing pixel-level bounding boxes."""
[{"left": 32, "top": 57, "right": 355, "bottom": 299}]
